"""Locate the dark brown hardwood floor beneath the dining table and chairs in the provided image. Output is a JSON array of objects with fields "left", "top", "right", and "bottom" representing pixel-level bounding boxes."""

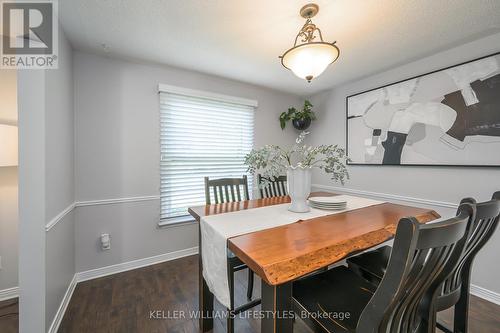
[{"left": 0, "top": 256, "right": 500, "bottom": 333}]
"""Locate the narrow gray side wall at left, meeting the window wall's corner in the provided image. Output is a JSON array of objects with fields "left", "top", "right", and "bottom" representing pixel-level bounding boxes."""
[{"left": 45, "top": 29, "right": 75, "bottom": 328}]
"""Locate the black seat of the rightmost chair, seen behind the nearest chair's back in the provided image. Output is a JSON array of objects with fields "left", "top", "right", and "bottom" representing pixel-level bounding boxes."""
[{"left": 347, "top": 246, "right": 392, "bottom": 284}]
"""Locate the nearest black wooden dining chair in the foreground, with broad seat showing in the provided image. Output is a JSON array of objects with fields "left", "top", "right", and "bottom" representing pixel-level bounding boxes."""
[{"left": 292, "top": 204, "right": 475, "bottom": 333}]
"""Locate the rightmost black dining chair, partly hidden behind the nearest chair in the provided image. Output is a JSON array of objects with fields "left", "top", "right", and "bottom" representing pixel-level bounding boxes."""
[{"left": 347, "top": 191, "right": 500, "bottom": 333}]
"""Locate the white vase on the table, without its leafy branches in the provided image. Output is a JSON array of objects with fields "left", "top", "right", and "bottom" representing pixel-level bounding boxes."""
[{"left": 286, "top": 167, "right": 311, "bottom": 213}]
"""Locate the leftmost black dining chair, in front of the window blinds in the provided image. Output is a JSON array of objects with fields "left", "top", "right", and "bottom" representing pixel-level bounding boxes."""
[{"left": 205, "top": 176, "right": 261, "bottom": 333}]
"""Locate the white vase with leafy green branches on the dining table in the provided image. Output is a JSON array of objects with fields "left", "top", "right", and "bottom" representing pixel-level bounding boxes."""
[{"left": 245, "top": 132, "right": 349, "bottom": 213}]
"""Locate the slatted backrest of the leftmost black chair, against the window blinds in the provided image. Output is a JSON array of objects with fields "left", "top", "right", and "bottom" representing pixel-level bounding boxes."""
[{"left": 205, "top": 176, "right": 250, "bottom": 205}]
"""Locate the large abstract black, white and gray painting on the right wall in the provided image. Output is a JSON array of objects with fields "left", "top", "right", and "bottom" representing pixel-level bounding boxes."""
[{"left": 347, "top": 53, "right": 500, "bottom": 166}]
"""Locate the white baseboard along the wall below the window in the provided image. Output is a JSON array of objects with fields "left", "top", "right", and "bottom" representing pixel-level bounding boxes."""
[{"left": 76, "top": 246, "right": 198, "bottom": 282}]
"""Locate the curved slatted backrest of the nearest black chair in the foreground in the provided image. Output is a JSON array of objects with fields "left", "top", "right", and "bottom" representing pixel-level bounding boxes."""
[{"left": 356, "top": 204, "right": 475, "bottom": 333}]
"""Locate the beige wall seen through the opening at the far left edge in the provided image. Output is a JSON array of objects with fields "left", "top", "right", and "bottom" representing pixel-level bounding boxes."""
[{"left": 0, "top": 69, "right": 19, "bottom": 290}]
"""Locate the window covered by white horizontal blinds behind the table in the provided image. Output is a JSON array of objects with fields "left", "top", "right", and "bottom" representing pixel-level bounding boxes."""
[{"left": 160, "top": 85, "right": 257, "bottom": 225}]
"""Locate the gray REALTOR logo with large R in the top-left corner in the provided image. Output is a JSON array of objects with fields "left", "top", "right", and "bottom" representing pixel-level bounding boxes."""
[{"left": 0, "top": 0, "right": 58, "bottom": 69}]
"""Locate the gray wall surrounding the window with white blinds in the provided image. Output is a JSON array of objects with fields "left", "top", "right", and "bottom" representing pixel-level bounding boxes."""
[{"left": 74, "top": 52, "right": 301, "bottom": 271}]
